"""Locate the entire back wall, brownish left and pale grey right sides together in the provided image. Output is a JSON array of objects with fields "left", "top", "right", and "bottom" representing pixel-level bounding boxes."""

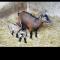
[{"left": 0, "top": 2, "right": 60, "bottom": 18}]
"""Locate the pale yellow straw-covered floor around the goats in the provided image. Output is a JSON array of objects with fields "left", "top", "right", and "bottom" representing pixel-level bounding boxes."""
[{"left": 0, "top": 17, "right": 60, "bottom": 47}]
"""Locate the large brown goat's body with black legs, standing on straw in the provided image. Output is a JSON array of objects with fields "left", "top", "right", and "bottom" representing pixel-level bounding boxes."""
[{"left": 16, "top": 11, "right": 50, "bottom": 38}]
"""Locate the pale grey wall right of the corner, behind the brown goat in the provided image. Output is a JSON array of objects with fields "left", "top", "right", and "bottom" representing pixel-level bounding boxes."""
[{"left": 28, "top": 2, "right": 60, "bottom": 16}]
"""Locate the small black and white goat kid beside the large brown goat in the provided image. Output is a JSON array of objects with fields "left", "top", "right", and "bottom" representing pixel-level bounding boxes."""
[{"left": 8, "top": 23, "right": 27, "bottom": 43}]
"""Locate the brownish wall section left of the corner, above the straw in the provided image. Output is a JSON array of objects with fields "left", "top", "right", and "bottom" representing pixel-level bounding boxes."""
[{"left": 0, "top": 2, "right": 27, "bottom": 18}]
